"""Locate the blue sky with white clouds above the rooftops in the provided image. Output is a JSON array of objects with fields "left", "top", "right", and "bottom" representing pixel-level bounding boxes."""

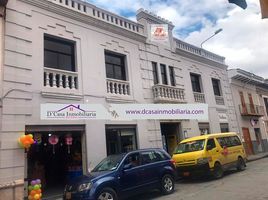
[{"left": 85, "top": 0, "right": 268, "bottom": 79}]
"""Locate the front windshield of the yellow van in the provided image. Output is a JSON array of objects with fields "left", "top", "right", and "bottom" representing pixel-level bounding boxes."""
[{"left": 174, "top": 140, "right": 205, "bottom": 154}]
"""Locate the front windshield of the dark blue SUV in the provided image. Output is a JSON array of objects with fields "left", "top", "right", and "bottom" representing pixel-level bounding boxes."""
[{"left": 92, "top": 154, "right": 124, "bottom": 172}]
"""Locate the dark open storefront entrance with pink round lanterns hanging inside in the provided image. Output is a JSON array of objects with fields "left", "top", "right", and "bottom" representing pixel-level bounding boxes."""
[{"left": 27, "top": 127, "right": 83, "bottom": 199}]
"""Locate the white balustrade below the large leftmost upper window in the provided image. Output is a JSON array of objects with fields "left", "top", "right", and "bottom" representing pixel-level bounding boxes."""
[{"left": 44, "top": 67, "right": 78, "bottom": 90}]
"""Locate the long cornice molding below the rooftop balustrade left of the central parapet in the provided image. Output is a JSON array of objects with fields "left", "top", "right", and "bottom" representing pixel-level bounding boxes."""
[{"left": 20, "top": 0, "right": 146, "bottom": 42}]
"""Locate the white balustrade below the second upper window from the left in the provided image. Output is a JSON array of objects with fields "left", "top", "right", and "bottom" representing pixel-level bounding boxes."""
[{"left": 106, "top": 78, "right": 130, "bottom": 95}]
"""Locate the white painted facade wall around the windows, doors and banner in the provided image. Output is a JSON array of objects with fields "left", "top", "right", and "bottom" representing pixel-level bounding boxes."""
[{"left": 0, "top": 0, "right": 237, "bottom": 191}]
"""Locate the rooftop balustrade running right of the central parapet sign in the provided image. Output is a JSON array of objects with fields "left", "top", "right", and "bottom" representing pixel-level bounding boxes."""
[{"left": 175, "top": 39, "right": 225, "bottom": 64}]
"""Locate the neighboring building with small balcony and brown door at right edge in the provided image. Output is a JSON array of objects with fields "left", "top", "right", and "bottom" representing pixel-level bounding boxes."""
[{"left": 228, "top": 69, "right": 268, "bottom": 155}]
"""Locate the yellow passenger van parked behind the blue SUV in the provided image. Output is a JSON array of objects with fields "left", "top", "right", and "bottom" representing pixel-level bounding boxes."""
[{"left": 172, "top": 133, "right": 246, "bottom": 178}]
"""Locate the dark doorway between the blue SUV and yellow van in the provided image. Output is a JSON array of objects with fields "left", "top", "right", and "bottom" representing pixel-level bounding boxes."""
[{"left": 160, "top": 123, "right": 181, "bottom": 155}]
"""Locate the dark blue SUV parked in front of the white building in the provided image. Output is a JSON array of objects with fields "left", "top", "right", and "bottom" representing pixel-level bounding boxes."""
[{"left": 64, "top": 149, "right": 176, "bottom": 200}]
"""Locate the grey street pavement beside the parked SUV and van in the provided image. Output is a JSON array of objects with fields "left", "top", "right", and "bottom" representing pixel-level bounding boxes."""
[{"left": 131, "top": 158, "right": 268, "bottom": 200}]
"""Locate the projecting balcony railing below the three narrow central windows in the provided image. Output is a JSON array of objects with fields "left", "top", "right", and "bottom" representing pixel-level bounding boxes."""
[{"left": 153, "top": 85, "right": 185, "bottom": 103}]
